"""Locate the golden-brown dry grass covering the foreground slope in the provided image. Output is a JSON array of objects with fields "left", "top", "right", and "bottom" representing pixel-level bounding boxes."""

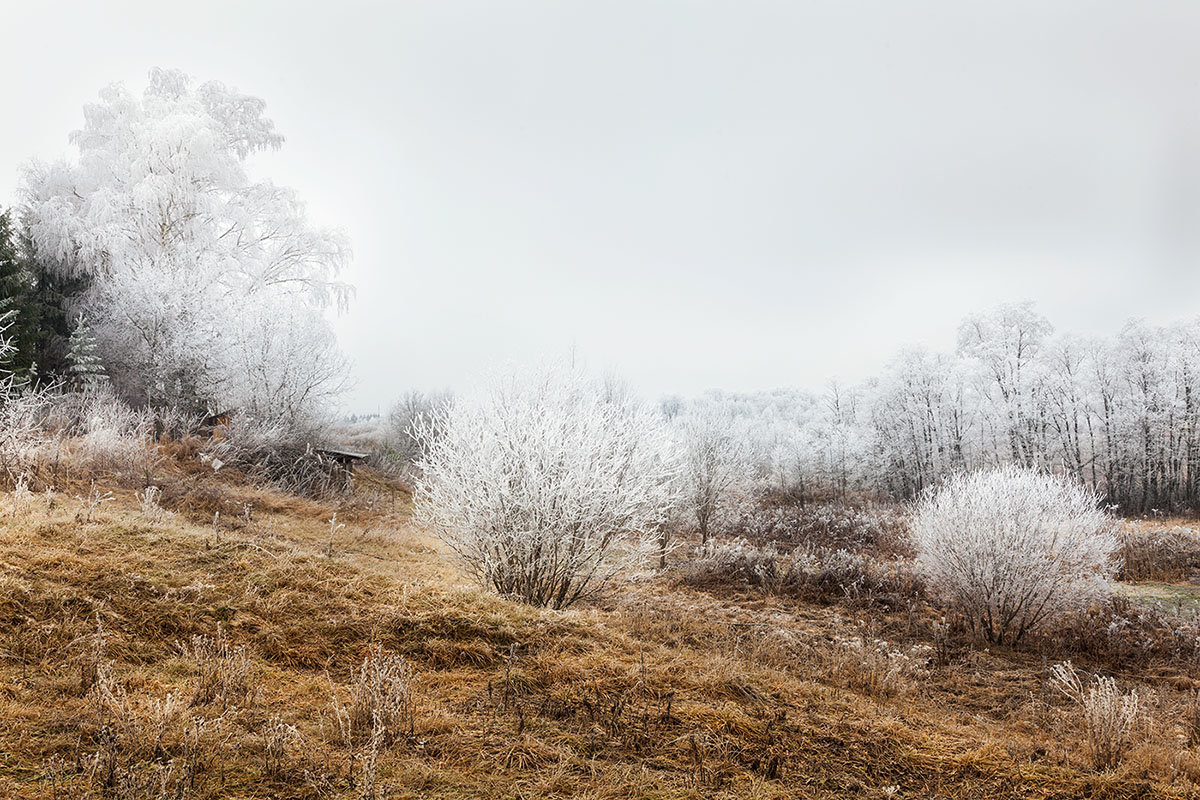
[{"left": 0, "top": 462, "right": 1200, "bottom": 800}]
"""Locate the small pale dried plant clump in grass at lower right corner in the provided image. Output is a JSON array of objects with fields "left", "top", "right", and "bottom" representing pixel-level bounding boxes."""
[{"left": 1050, "top": 661, "right": 1142, "bottom": 770}]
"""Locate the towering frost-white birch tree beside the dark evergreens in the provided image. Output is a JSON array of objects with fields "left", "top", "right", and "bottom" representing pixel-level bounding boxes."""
[{"left": 22, "top": 70, "right": 349, "bottom": 424}]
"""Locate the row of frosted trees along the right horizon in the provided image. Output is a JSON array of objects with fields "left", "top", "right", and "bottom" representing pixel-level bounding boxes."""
[{"left": 664, "top": 303, "right": 1200, "bottom": 513}]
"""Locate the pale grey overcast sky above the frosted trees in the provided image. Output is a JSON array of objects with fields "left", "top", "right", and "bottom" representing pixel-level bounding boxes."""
[{"left": 0, "top": 0, "right": 1200, "bottom": 410}]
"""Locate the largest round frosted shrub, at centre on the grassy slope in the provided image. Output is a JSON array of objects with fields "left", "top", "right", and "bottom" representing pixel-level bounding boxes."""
[{"left": 416, "top": 369, "right": 678, "bottom": 608}]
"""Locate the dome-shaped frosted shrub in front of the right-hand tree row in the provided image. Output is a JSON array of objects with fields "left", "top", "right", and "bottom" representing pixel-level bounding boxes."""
[{"left": 912, "top": 465, "right": 1117, "bottom": 643}]
